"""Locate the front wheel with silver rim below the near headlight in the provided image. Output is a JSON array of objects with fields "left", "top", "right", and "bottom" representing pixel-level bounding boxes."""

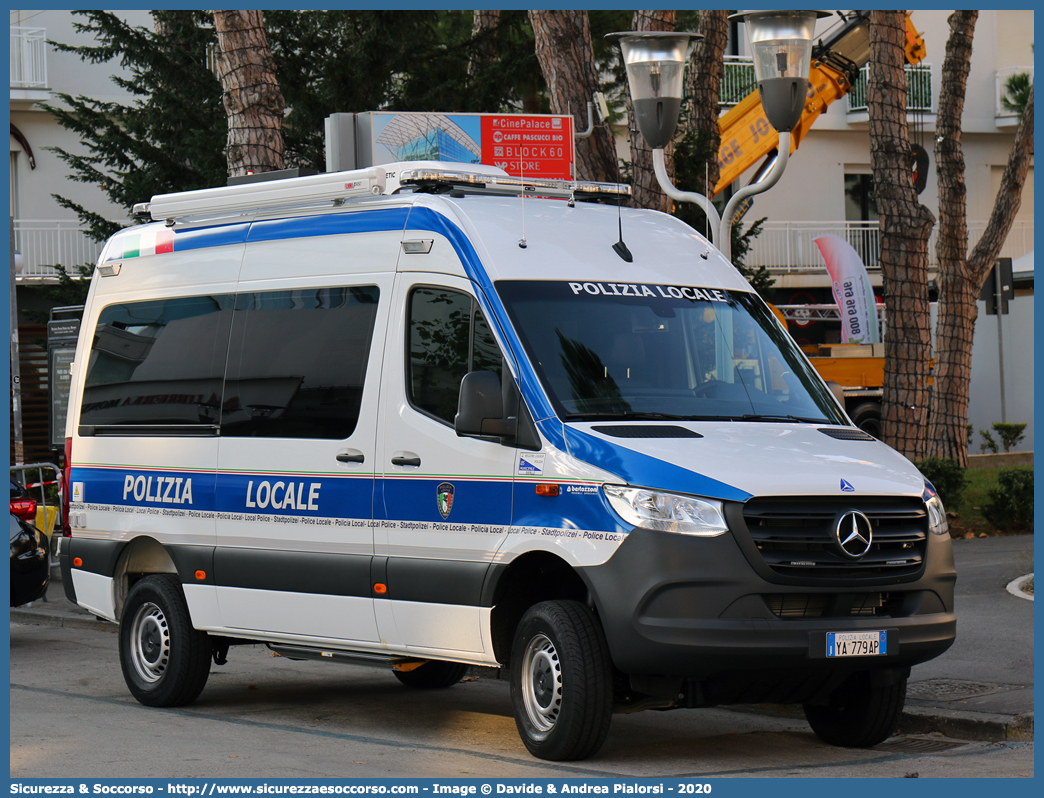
[{"left": 512, "top": 602, "right": 613, "bottom": 761}]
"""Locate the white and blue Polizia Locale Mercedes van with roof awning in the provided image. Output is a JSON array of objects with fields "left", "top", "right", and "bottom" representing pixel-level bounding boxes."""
[{"left": 60, "top": 162, "right": 956, "bottom": 759}]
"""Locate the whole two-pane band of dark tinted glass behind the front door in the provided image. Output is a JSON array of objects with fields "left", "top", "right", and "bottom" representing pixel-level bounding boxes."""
[{"left": 79, "top": 285, "right": 379, "bottom": 440}]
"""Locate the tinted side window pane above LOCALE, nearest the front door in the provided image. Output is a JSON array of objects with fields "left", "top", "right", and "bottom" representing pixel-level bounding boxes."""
[{"left": 221, "top": 285, "right": 379, "bottom": 440}]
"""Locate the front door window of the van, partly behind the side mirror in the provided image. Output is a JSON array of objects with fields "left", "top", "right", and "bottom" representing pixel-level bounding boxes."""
[{"left": 406, "top": 288, "right": 504, "bottom": 424}]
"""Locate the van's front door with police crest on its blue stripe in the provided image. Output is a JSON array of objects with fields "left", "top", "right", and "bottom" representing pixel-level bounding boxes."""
[{"left": 374, "top": 273, "right": 517, "bottom": 656}]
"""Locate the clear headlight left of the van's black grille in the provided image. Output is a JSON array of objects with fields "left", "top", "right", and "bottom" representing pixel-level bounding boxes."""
[{"left": 601, "top": 485, "right": 729, "bottom": 538}]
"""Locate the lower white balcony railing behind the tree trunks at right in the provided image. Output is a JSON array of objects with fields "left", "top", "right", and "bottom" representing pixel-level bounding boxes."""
[{"left": 745, "top": 221, "right": 1034, "bottom": 273}]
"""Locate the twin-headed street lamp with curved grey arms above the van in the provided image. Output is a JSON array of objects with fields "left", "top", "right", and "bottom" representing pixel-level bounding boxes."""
[{"left": 607, "top": 10, "right": 828, "bottom": 260}]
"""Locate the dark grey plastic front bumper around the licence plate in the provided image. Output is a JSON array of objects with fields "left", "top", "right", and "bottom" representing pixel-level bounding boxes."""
[{"left": 583, "top": 518, "right": 956, "bottom": 681}]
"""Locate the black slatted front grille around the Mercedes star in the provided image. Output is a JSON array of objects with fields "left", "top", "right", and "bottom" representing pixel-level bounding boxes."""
[{"left": 743, "top": 496, "right": 928, "bottom": 579}]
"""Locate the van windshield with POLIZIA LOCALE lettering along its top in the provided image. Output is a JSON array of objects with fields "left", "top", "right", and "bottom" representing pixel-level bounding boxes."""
[{"left": 496, "top": 280, "right": 847, "bottom": 424}]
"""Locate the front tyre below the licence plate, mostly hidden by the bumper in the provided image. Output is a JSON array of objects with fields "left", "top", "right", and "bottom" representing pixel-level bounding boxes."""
[{"left": 804, "top": 674, "right": 906, "bottom": 748}]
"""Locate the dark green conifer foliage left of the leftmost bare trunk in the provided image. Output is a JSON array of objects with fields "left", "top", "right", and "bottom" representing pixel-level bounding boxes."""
[{"left": 47, "top": 10, "right": 227, "bottom": 241}]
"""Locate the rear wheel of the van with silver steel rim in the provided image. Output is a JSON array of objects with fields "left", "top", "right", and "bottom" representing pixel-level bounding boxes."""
[{"left": 120, "top": 573, "right": 211, "bottom": 706}]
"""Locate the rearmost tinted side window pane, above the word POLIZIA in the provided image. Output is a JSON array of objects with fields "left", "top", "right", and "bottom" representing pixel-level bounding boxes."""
[{"left": 79, "top": 295, "right": 234, "bottom": 426}]
